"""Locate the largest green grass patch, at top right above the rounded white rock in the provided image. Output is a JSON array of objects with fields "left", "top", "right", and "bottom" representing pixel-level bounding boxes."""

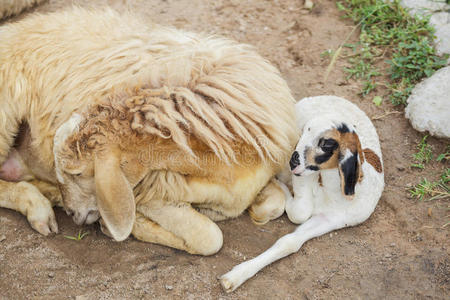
[{"left": 337, "top": 0, "right": 448, "bottom": 105}]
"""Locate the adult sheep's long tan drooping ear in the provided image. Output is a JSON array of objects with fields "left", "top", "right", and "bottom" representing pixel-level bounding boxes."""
[{"left": 95, "top": 148, "right": 136, "bottom": 241}]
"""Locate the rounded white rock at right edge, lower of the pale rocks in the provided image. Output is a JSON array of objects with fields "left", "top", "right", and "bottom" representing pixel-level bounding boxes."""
[{"left": 405, "top": 67, "right": 450, "bottom": 138}]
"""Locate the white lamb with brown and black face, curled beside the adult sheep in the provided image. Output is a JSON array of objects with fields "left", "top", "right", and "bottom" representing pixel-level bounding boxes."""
[{"left": 220, "top": 96, "right": 384, "bottom": 292}]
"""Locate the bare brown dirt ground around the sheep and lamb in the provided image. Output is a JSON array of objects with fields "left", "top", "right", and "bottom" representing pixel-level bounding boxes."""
[{"left": 0, "top": 0, "right": 450, "bottom": 299}]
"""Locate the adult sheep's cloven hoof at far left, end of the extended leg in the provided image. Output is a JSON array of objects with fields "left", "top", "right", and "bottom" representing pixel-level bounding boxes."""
[{"left": 27, "top": 204, "right": 58, "bottom": 236}]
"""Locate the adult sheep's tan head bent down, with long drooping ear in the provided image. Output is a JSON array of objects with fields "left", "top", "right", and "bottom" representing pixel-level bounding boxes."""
[{"left": 53, "top": 114, "right": 145, "bottom": 241}]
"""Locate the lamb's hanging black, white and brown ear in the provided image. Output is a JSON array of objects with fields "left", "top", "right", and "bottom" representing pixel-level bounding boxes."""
[{"left": 339, "top": 132, "right": 363, "bottom": 199}]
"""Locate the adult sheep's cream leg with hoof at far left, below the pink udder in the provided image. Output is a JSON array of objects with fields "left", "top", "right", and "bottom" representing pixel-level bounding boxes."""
[{"left": 0, "top": 180, "right": 58, "bottom": 235}]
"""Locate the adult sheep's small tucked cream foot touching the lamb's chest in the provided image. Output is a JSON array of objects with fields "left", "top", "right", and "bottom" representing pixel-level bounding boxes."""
[{"left": 248, "top": 179, "right": 286, "bottom": 225}]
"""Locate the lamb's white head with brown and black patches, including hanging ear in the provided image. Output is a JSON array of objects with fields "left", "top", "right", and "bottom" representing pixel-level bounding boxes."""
[{"left": 289, "top": 116, "right": 364, "bottom": 198}]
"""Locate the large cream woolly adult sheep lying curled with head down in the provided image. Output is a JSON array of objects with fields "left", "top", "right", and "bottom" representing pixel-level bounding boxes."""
[{"left": 0, "top": 9, "right": 297, "bottom": 255}]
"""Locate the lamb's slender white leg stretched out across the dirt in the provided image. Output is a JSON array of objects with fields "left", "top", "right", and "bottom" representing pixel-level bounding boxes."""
[{"left": 220, "top": 214, "right": 345, "bottom": 292}]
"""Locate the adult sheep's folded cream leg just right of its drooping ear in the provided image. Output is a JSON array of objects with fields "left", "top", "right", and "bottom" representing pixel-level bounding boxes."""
[{"left": 133, "top": 200, "right": 223, "bottom": 255}]
